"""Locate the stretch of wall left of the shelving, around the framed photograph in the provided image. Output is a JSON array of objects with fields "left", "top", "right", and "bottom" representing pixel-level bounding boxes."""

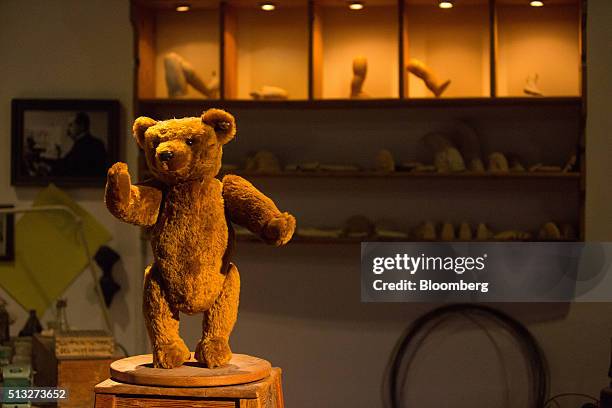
[{"left": 0, "top": 0, "right": 142, "bottom": 352}]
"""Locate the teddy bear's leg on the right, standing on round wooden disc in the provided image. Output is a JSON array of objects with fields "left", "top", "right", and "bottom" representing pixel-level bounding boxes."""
[{"left": 195, "top": 264, "right": 240, "bottom": 368}]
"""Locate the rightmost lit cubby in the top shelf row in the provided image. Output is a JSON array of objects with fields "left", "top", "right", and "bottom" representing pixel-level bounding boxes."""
[{"left": 494, "top": 0, "right": 581, "bottom": 96}]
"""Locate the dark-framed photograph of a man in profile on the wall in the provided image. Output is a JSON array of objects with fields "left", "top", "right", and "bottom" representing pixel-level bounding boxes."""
[{"left": 11, "top": 99, "right": 119, "bottom": 187}]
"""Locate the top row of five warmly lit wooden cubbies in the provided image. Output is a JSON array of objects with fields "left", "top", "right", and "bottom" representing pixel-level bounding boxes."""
[{"left": 132, "top": 0, "right": 582, "bottom": 100}]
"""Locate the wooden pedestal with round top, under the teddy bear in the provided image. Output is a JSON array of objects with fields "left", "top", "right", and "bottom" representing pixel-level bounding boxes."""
[{"left": 95, "top": 354, "right": 284, "bottom": 408}]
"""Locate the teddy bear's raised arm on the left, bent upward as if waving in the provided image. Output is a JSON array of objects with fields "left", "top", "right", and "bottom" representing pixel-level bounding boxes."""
[{"left": 104, "top": 163, "right": 162, "bottom": 227}]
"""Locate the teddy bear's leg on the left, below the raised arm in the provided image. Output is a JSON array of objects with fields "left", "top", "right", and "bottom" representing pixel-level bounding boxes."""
[{"left": 142, "top": 264, "right": 191, "bottom": 368}]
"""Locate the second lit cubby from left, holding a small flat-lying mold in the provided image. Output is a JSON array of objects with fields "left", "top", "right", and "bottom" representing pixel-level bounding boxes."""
[{"left": 221, "top": 0, "right": 309, "bottom": 99}]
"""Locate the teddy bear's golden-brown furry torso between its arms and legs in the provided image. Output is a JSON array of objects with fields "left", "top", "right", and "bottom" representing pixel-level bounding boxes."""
[{"left": 151, "top": 178, "right": 228, "bottom": 313}]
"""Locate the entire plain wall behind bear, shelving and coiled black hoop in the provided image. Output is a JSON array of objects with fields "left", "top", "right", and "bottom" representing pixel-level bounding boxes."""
[{"left": 0, "top": 0, "right": 612, "bottom": 408}]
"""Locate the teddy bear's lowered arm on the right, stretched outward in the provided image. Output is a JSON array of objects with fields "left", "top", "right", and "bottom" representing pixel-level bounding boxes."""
[{"left": 223, "top": 174, "right": 295, "bottom": 246}]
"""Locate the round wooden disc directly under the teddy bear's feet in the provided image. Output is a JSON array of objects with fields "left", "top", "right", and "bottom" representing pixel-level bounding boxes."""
[{"left": 110, "top": 353, "right": 272, "bottom": 387}]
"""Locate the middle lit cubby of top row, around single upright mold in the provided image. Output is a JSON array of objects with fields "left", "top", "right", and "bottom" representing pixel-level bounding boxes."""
[{"left": 311, "top": 0, "right": 399, "bottom": 99}]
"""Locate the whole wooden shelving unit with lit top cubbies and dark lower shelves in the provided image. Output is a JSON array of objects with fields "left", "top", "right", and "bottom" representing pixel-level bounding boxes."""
[{"left": 132, "top": 0, "right": 586, "bottom": 244}]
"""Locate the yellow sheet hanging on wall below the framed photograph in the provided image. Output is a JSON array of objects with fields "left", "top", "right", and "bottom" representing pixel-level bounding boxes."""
[{"left": 0, "top": 184, "right": 112, "bottom": 316}]
